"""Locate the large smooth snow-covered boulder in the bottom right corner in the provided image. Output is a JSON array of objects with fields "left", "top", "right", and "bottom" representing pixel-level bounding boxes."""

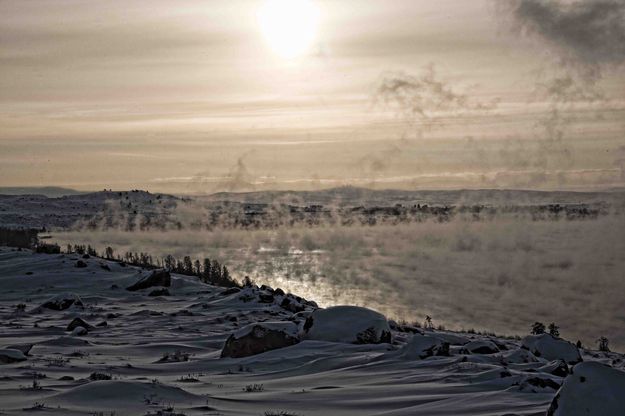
[{"left": 547, "top": 362, "right": 625, "bottom": 416}]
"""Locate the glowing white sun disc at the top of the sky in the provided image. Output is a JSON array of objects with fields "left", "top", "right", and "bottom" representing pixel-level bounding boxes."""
[{"left": 257, "top": 0, "right": 319, "bottom": 59}]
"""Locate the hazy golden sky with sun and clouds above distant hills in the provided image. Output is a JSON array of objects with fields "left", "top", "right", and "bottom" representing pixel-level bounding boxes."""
[{"left": 0, "top": 0, "right": 625, "bottom": 193}]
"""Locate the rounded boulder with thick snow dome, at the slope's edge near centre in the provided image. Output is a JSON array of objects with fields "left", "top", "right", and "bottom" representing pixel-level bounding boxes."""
[{"left": 303, "top": 306, "right": 392, "bottom": 344}]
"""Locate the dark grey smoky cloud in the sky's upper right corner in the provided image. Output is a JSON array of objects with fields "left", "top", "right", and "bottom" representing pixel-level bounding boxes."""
[{"left": 502, "top": 0, "right": 625, "bottom": 75}]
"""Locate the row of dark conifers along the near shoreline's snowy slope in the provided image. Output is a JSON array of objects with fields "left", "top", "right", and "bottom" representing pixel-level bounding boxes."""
[{"left": 65, "top": 244, "right": 242, "bottom": 287}]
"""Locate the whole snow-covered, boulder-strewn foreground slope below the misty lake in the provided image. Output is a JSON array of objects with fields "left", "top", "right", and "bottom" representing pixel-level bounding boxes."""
[{"left": 0, "top": 248, "right": 625, "bottom": 416}]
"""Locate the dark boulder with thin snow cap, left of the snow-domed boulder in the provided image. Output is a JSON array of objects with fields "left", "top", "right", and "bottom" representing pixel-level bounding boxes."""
[{"left": 221, "top": 322, "right": 299, "bottom": 358}]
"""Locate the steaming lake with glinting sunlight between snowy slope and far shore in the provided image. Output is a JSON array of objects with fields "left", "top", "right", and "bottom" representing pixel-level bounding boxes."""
[{"left": 55, "top": 215, "right": 625, "bottom": 349}]
